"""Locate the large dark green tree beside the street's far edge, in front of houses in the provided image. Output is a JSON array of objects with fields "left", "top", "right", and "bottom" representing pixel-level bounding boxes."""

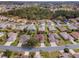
[{"left": 22, "top": 38, "right": 39, "bottom": 48}]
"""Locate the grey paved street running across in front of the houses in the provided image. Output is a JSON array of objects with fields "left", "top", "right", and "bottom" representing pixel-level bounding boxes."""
[{"left": 0, "top": 44, "right": 79, "bottom": 52}]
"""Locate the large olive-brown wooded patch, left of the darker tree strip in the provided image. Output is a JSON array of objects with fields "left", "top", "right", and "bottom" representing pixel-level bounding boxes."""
[{"left": 2, "top": 7, "right": 52, "bottom": 20}]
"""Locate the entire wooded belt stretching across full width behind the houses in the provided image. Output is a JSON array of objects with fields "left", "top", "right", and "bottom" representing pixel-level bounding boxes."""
[{"left": 1, "top": 7, "right": 79, "bottom": 20}]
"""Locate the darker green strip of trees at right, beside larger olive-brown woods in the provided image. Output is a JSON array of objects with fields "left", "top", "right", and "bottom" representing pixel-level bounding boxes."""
[{"left": 53, "top": 10, "right": 79, "bottom": 19}]
